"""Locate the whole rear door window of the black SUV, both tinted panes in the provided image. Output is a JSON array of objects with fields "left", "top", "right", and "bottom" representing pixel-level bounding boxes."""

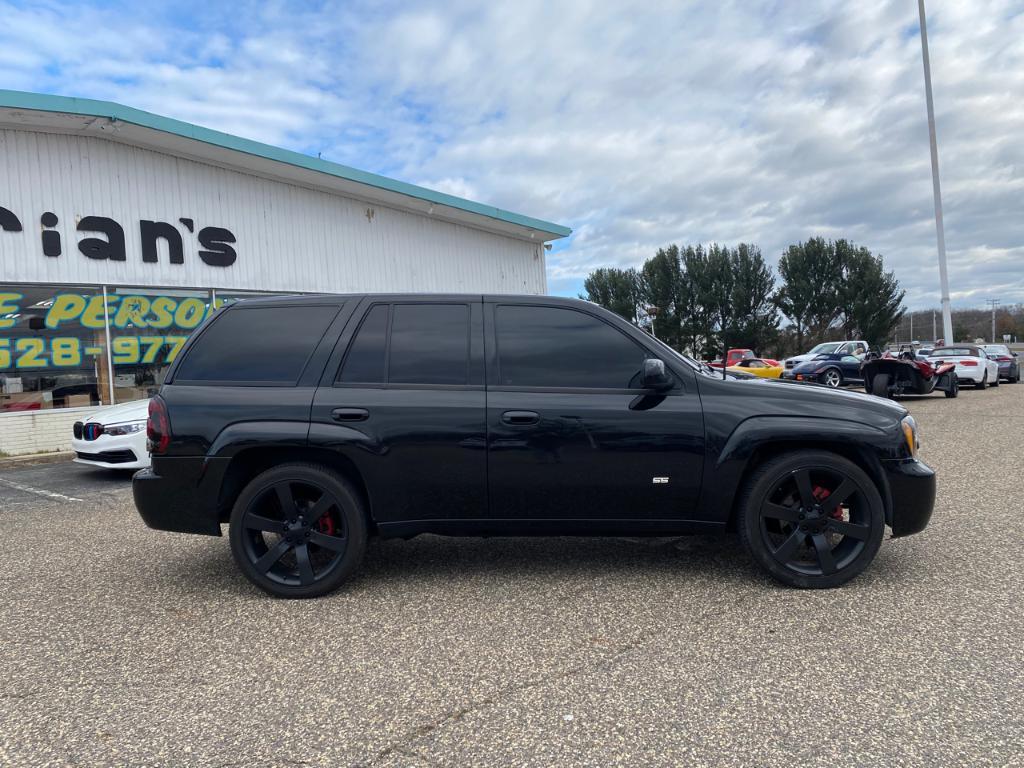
[{"left": 338, "top": 304, "right": 469, "bottom": 385}]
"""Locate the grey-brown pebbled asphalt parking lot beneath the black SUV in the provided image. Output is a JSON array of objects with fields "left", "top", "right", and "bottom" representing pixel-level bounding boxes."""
[{"left": 0, "top": 385, "right": 1024, "bottom": 766}]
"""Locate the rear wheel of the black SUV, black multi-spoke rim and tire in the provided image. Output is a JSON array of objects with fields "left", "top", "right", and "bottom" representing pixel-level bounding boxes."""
[{"left": 228, "top": 463, "right": 367, "bottom": 598}]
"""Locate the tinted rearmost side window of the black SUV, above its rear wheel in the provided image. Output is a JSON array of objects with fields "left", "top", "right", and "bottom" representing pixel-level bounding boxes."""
[{"left": 175, "top": 305, "right": 338, "bottom": 384}]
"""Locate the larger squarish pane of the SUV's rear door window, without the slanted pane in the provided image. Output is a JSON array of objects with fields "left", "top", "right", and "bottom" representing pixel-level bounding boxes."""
[{"left": 388, "top": 304, "right": 469, "bottom": 384}]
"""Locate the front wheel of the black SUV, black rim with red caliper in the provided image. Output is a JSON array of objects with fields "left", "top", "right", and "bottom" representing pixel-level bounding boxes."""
[{"left": 738, "top": 451, "right": 886, "bottom": 589}]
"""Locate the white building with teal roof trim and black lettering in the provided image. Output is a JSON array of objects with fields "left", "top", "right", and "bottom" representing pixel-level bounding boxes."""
[{"left": 0, "top": 90, "right": 569, "bottom": 455}]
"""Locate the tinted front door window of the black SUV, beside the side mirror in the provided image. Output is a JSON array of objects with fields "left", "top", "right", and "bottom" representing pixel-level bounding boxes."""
[{"left": 496, "top": 306, "right": 645, "bottom": 389}]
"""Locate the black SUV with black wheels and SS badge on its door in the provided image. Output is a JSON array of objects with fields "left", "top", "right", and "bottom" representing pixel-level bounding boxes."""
[{"left": 132, "top": 294, "right": 935, "bottom": 597}]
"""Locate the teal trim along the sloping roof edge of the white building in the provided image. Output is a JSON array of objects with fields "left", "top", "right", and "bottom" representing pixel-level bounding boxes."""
[{"left": 0, "top": 89, "right": 572, "bottom": 238}]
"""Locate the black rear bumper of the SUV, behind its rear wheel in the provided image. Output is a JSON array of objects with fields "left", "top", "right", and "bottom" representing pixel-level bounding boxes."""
[{"left": 131, "top": 459, "right": 226, "bottom": 536}]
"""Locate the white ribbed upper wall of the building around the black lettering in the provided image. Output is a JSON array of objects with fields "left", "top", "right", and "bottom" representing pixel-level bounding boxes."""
[{"left": 0, "top": 130, "right": 545, "bottom": 293}]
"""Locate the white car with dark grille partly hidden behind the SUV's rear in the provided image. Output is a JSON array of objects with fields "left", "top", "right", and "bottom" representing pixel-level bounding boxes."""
[{"left": 71, "top": 399, "right": 150, "bottom": 469}]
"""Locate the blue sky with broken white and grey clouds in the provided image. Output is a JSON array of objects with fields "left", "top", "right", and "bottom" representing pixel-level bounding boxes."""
[{"left": 0, "top": 0, "right": 1024, "bottom": 307}]
